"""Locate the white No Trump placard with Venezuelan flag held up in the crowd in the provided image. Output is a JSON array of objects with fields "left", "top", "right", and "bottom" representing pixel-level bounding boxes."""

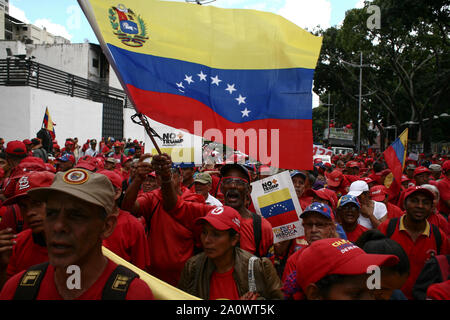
[{"left": 251, "top": 171, "right": 304, "bottom": 243}]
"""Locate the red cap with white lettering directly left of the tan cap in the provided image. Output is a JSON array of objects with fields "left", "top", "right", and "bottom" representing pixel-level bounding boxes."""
[{"left": 3, "top": 171, "right": 55, "bottom": 205}]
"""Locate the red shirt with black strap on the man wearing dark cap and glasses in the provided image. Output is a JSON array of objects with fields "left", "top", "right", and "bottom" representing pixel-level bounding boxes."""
[{"left": 239, "top": 217, "right": 273, "bottom": 256}]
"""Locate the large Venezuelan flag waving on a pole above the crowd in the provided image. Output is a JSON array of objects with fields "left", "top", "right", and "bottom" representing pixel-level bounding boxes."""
[{"left": 78, "top": 0, "right": 322, "bottom": 169}]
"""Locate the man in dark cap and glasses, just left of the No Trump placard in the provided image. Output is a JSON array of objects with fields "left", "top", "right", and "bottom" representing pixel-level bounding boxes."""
[{"left": 220, "top": 163, "right": 273, "bottom": 257}]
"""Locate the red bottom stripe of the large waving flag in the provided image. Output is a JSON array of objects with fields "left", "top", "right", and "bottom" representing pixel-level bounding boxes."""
[{"left": 128, "top": 85, "right": 313, "bottom": 170}]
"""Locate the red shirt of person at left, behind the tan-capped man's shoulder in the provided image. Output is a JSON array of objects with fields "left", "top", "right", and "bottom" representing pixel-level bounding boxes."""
[{"left": 6, "top": 229, "right": 48, "bottom": 277}]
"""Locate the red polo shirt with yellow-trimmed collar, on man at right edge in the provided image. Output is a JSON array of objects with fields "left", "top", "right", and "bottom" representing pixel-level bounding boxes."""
[{"left": 378, "top": 215, "right": 450, "bottom": 299}]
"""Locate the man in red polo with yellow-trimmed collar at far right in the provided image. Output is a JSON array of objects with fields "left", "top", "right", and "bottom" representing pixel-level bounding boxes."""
[{"left": 378, "top": 186, "right": 450, "bottom": 299}]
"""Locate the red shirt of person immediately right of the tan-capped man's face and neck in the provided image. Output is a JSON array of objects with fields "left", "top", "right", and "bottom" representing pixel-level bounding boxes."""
[{"left": 103, "top": 210, "right": 150, "bottom": 270}]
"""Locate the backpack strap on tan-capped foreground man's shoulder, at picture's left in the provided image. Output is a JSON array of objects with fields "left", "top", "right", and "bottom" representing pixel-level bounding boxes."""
[{"left": 13, "top": 262, "right": 49, "bottom": 300}]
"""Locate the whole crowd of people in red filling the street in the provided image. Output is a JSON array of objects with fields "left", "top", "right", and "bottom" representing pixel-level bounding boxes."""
[{"left": 0, "top": 137, "right": 450, "bottom": 300}]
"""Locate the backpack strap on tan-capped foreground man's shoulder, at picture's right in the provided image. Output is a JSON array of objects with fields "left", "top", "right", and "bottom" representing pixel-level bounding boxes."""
[{"left": 102, "top": 265, "right": 139, "bottom": 300}]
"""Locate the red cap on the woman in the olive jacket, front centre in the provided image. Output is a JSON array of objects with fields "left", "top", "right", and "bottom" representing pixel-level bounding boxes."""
[{"left": 195, "top": 206, "right": 241, "bottom": 232}]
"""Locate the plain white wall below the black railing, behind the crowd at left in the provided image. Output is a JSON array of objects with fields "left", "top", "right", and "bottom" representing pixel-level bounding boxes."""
[{"left": 0, "top": 87, "right": 103, "bottom": 146}]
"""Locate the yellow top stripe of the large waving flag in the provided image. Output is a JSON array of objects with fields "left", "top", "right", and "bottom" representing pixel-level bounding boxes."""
[{"left": 79, "top": 0, "right": 322, "bottom": 70}]
